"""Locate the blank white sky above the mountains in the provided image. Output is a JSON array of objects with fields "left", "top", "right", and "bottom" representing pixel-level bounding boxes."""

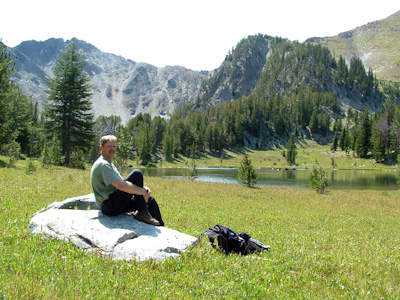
[{"left": 0, "top": 0, "right": 400, "bottom": 71}]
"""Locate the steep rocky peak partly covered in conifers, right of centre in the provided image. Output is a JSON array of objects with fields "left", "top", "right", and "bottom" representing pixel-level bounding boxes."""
[{"left": 189, "top": 34, "right": 385, "bottom": 116}]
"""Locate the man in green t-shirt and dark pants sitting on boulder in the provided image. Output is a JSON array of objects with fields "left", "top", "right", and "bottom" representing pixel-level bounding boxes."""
[{"left": 90, "top": 135, "right": 164, "bottom": 226}]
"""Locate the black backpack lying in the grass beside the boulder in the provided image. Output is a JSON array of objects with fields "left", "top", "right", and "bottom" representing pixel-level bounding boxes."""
[{"left": 202, "top": 224, "right": 271, "bottom": 255}]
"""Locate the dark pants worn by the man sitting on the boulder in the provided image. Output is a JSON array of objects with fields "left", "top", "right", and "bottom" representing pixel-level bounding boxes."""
[{"left": 101, "top": 170, "right": 164, "bottom": 226}]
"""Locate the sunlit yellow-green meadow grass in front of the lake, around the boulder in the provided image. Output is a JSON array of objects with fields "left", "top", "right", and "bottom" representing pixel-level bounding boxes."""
[{"left": 0, "top": 162, "right": 400, "bottom": 299}]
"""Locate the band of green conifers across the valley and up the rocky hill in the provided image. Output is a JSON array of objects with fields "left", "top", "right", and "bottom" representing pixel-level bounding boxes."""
[{"left": 0, "top": 39, "right": 400, "bottom": 168}]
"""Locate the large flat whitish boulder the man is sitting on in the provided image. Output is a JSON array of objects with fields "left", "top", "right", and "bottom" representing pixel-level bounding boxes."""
[{"left": 29, "top": 194, "right": 197, "bottom": 261}]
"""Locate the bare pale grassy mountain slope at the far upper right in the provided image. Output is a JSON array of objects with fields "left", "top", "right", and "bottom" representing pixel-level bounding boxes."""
[{"left": 306, "top": 11, "right": 400, "bottom": 82}]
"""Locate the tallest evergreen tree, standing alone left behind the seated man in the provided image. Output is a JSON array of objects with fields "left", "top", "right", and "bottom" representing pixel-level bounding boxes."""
[{"left": 44, "top": 40, "right": 94, "bottom": 166}]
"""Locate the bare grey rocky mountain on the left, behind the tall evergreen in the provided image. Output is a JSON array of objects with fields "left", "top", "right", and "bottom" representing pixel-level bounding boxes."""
[{"left": 10, "top": 39, "right": 208, "bottom": 122}]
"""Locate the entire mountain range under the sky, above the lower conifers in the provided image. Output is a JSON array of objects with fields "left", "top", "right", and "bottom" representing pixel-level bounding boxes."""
[{"left": 9, "top": 12, "right": 400, "bottom": 122}]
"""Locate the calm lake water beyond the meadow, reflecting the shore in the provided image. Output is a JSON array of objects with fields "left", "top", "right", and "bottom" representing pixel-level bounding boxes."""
[{"left": 145, "top": 168, "right": 399, "bottom": 190}]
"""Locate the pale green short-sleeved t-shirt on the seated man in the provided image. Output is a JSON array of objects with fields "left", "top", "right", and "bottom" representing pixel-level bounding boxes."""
[{"left": 90, "top": 155, "right": 123, "bottom": 206}]
